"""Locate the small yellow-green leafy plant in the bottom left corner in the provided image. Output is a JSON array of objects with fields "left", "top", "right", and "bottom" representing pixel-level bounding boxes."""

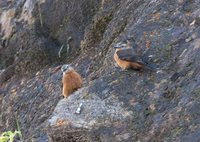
[{"left": 0, "top": 131, "right": 22, "bottom": 142}]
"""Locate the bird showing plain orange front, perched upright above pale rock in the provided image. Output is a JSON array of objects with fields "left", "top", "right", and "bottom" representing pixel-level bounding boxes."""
[{"left": 61, "top": 64, "right": 83, "bottom": 98}]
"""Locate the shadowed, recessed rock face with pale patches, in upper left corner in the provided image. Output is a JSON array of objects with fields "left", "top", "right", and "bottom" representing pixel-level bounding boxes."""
[{"left": 0, "top": 0, "right": 98, "bottom": 83}]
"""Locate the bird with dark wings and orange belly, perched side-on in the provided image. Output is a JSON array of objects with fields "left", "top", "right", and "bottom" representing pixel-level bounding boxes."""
[{"left": 114, "top": 39, "right": 153, "bottom": 70}]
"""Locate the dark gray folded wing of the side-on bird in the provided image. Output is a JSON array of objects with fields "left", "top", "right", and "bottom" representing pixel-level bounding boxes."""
[{"left": 116, "top": 48, "right": 146, "bottom": 64}]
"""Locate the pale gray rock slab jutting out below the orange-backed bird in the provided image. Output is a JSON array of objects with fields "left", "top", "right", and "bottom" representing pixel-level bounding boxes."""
[{"left": 49, "top": 88, "right": 133, "bottom": 130}]
